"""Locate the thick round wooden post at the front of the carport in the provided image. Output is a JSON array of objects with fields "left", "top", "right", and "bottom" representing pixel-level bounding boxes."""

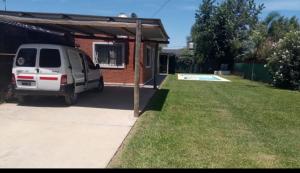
[{"left": 134, "top": 20, "right": 142, "bottom": 117}]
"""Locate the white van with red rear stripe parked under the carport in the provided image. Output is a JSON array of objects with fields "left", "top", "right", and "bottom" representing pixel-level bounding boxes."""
[{"left": 12, "top": 44, "right": 104, "bottom": 105}]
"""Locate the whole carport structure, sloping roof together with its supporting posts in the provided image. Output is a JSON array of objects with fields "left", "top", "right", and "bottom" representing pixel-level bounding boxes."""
[{"left": 0, "top": 11, "right": 169, "bottom": 117}]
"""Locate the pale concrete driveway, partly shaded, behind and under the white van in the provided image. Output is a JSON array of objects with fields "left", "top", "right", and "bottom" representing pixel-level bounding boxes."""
[{"left": 0, "top": 87, "right": 154, "bottom": 168}]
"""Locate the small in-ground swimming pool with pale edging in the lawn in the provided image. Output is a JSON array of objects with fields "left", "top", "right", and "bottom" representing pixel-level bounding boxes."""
[{"left": 178, "top": 74, "right": 230, "bottom": 82}]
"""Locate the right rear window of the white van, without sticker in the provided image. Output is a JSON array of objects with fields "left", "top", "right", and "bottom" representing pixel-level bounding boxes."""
[{"left": 40, "top": 49, "right": 61, "bottom": 68}]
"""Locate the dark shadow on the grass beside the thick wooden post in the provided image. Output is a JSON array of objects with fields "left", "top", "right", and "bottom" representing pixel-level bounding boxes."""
[{"left": 142, "top": 89, "right": 169, "bottom": 114}]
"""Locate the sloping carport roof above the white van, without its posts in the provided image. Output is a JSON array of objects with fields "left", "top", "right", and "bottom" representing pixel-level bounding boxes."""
[{"left": 0, "top": 11, "right": 169, "bottom": 43}]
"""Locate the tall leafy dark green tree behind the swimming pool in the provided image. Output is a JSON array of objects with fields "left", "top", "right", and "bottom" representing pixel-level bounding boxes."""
[{"left": 192, "top": 0, "right": 264, "bottom": 71}]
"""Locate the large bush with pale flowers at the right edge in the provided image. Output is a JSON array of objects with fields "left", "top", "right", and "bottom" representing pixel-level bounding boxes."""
[{"left": 267, "top": 31, "right": 300, "bottom": 89}]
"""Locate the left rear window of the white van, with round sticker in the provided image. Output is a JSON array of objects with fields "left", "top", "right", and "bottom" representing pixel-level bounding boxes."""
[{"left": 16, "top": 48, "right": 37, "bottom": 67}]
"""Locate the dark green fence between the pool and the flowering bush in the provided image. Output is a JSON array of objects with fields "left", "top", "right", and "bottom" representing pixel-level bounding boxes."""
[{"left": 234, "top": 63, "right": 272, "bottom": 83}]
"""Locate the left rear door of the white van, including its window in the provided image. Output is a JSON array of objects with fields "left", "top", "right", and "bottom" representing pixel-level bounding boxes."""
[{"left": 13, "top": 48, "right": 38, "bottom": 90}]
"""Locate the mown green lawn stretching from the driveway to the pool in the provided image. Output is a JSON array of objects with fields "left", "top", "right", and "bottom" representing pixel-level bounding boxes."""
[{"left": 109, "top": 75, "right": 300, "bottom": 168}]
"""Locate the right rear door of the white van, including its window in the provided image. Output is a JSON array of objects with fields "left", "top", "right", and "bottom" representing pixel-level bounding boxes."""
[{"left": 37, "top": 48, "right": 62, "bottom": 91}]
